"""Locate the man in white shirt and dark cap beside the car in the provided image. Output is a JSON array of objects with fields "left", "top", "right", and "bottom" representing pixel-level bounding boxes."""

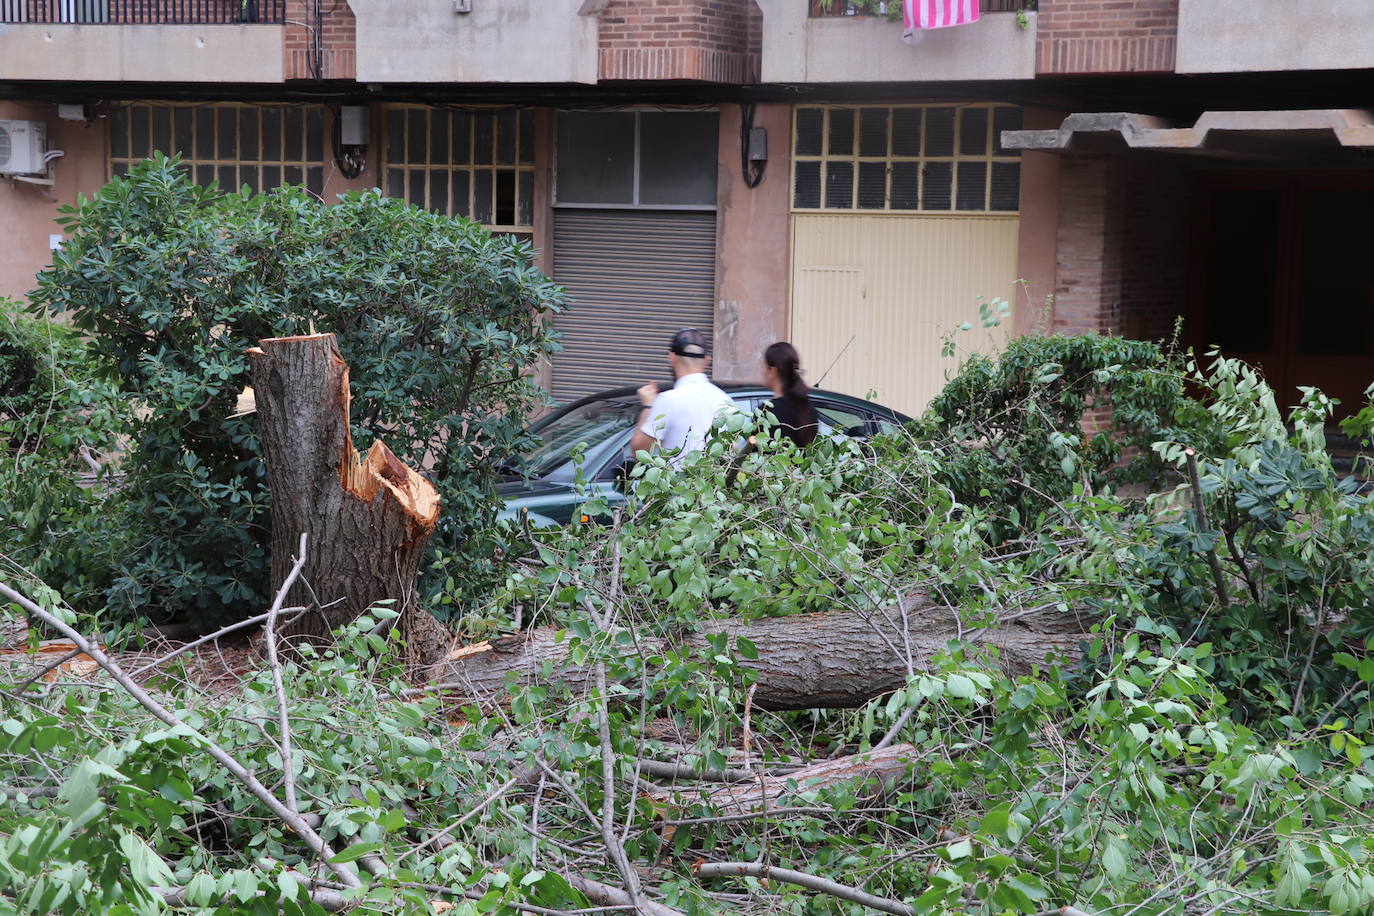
[{"left": 629, "top": 328, "right": 739, "bottom": 467}]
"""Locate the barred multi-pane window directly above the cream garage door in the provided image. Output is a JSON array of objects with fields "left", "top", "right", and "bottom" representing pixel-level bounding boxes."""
[{"left": 793, "top": 104, "right": 1021, "bottom": 213}]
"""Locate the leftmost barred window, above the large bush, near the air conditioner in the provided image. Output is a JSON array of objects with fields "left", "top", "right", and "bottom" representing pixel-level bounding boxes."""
[{"left": 110, "top": 102, "right": 324, "bottom": 195}]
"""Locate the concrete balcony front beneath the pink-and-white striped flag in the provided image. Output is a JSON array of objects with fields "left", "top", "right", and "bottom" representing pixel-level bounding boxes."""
[{"left": 758, "top": 0, "right": 1036, "bottom": 82}]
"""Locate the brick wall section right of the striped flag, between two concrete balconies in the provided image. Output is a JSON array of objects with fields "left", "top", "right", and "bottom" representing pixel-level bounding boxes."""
[{"left": 1036, "top": 0, "right": 1179, "bottom": 73}]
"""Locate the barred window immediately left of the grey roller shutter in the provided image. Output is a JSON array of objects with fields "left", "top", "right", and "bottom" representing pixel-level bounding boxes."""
[{"left": 386, "top": 106, "right": 534, "bottom": 232}]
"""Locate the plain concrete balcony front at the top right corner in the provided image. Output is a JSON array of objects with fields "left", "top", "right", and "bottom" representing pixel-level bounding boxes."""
[{"left": 1178, "top": 0, "right": 1374, "bottom": 73}]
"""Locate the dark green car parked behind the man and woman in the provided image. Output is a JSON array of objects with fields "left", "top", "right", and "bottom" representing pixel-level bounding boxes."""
[{"left": 497, "top": 382, "right": 911, "bottom": 527}]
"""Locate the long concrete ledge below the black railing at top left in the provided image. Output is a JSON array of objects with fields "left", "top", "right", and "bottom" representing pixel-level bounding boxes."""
[{"left": 0, "top": 23, "right": 284, "bottom": 82}]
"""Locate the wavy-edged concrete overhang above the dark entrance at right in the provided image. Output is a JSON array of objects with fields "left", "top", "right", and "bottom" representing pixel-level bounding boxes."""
[{"left": 1002, "top": 108, "right": 1374, "bottom": 161}]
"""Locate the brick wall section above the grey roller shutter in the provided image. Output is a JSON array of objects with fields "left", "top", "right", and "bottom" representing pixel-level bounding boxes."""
[{"left": 598, "top": 0, "right": 761, "bottom": 82}]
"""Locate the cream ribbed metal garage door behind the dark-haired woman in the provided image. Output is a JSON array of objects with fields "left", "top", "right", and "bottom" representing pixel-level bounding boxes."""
[{"left": 791, "top": 213, "right": 1018, "bottom": 415}]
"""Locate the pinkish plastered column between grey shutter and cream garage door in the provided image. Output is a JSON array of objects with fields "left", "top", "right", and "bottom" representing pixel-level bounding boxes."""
[{"left": 712, "top": 103, "right": 791, "bottom": 380}]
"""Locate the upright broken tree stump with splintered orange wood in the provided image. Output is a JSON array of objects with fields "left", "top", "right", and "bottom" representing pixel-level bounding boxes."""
[{"left": 249, "top": 334, "right": 452, "bottom": 670}]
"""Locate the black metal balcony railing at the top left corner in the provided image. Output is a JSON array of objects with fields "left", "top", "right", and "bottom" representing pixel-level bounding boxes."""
[{"left": 0, "top": 0, "right": 286, "bottom": 26}]
